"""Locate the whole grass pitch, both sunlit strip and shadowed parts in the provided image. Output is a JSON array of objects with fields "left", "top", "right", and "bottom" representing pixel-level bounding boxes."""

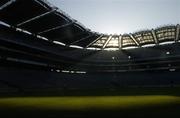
[{"left": 0, "top": 88, "right": 180, "bottom": 118}]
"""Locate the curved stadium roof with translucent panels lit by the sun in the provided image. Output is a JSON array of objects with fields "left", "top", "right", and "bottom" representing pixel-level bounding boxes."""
[{"left": 0, "top": 0, "right": 180, "bottom": 50}]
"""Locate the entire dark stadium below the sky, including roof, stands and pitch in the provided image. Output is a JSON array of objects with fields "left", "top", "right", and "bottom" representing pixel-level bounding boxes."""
[{"left": 0, "top": 0, "right": 180, "bottom": 118}]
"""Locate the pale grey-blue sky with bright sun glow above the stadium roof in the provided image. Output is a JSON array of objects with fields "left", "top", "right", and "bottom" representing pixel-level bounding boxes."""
[{"left": 48, "top": 0, "right": 180, "bottom": 34}]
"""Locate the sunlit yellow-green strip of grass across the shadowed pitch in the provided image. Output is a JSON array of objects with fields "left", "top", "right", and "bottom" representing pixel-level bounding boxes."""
[{"left": 0, "top": 95, "right": 180, "bottom": 110}]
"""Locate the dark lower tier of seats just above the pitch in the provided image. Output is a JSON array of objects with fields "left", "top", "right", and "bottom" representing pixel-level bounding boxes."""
[{"left": 0, "top": 68, "right": 180, "bottom": 90}]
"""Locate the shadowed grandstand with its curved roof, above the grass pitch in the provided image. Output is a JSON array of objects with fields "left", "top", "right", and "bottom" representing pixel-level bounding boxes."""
[{"left": 0, "top": 0, "right": 180, "bottom": 118}]
